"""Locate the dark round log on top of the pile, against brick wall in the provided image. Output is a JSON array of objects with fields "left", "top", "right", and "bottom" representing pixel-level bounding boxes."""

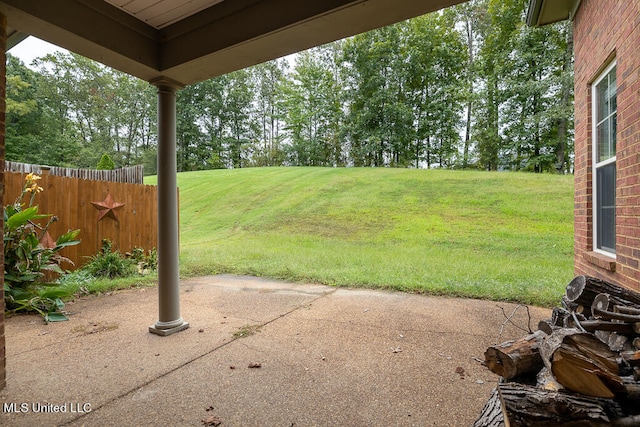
[{"left": 566, "top": 276, "right": 640, "bottom": 308}]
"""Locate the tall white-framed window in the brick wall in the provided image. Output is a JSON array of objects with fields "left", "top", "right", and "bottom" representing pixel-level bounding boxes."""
[{"left": 591, "top": 61, "right": 618, "bottom": 257}]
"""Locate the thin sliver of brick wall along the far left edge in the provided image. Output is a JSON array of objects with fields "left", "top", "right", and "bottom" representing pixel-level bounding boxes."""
[{"left": 0, "top": 14, "right": 7, "bottom": 390}]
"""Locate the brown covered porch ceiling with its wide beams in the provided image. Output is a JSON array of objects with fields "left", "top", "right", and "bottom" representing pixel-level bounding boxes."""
[{"left": 0, "top": 0, "right": 465, "bottom": 85}]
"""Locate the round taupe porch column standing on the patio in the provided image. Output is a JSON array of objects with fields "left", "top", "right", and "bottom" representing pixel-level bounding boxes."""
[{"left": 149, "top": 77, "right": 189, "bottom": 336}]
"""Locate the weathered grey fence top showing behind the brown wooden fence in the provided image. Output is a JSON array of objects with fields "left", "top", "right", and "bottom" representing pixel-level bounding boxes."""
[{"left": 4, "top": 161, "right": 144, "bottom": 184}]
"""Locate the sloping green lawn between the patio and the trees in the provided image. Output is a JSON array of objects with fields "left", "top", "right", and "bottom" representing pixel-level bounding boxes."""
[{"left": 147, "top": 168, "right": 573, "bottom": 305}]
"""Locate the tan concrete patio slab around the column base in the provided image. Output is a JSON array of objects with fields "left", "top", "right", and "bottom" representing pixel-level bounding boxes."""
[{"left": 0, "top": 276, "right": 550, "bottom": 427}]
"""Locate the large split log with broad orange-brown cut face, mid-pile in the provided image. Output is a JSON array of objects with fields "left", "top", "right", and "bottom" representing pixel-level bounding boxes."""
[{"left": 540, "top": 329, "right": 622, "bottom": 398}]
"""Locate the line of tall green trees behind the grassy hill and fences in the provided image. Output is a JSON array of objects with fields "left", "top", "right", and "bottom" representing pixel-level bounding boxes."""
[{"left": 6, "top": 0, "right": 573, "bottom": 173}]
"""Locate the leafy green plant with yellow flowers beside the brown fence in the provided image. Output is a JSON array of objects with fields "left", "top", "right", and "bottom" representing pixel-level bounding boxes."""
[{"left": 4, "top": 174, "right": 80, "bottom": 322}]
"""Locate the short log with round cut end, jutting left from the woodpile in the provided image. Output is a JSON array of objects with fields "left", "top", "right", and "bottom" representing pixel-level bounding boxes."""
[{"left": 484, "top": 330, "right": 547, "bottom": 380}]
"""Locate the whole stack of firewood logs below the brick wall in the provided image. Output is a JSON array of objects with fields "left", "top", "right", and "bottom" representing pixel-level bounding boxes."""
[{"left": 473, "top": 276, "right": 640, "bottom": 427}]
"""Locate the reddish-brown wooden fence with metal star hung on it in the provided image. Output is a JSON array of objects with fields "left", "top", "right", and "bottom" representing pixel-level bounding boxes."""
[{"left": 4, "top": 172, "right": 158, "bottom": 270}]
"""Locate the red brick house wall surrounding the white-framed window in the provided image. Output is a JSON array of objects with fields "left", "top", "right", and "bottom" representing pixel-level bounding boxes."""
[{"left": 574, "top": 0, "right": 640, "bottom": 290}]
